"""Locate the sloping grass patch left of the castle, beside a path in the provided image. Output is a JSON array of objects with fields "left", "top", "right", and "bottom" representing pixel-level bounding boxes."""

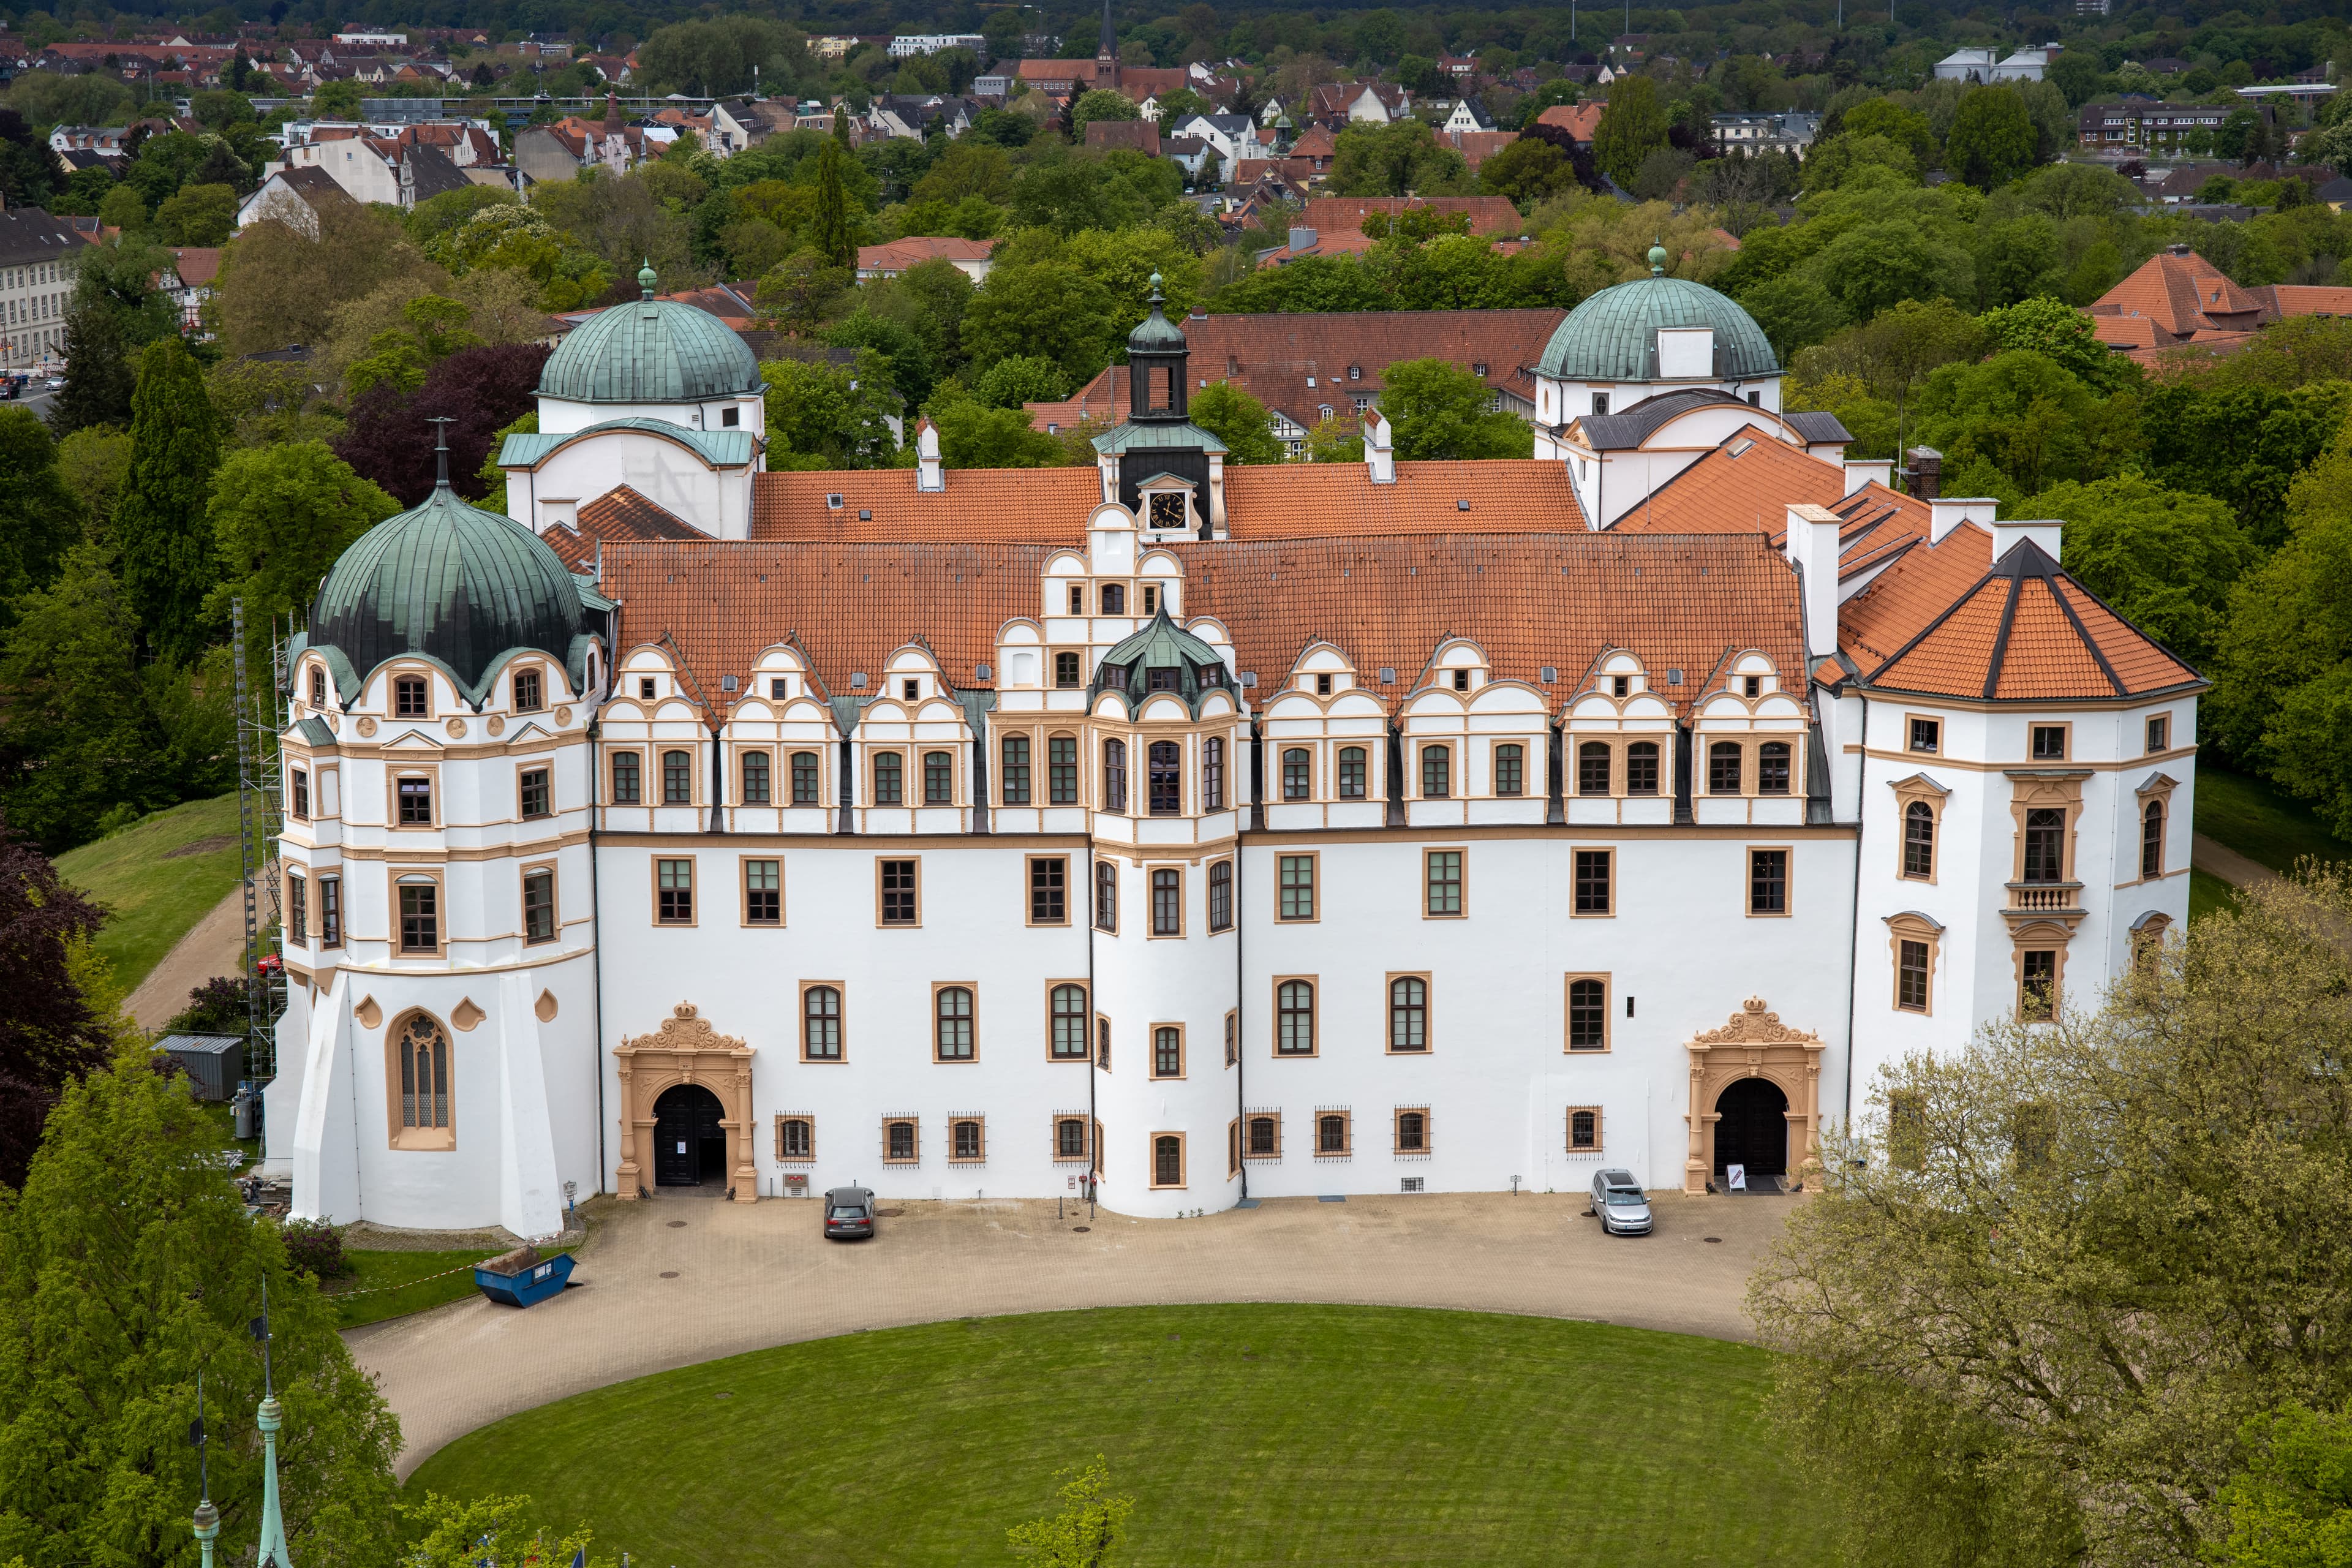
[{"left": 56, "top": 794, "right": 240, "bottom": 992}]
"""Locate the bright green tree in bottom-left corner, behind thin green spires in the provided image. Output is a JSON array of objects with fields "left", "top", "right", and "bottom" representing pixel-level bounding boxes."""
[{"left": 0, "top": 1034, "right": 400, "bottom": 1568}]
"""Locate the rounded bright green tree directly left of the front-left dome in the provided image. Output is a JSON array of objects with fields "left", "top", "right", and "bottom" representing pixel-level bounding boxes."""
[{"left": 205, "top": 442, "right": 400, "bottom": 625}]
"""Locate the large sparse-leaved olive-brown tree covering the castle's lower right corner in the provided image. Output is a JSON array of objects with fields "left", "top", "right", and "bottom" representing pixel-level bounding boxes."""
[{"left": 1747, "top": 867, "right": 2352, "bottom": 1568}]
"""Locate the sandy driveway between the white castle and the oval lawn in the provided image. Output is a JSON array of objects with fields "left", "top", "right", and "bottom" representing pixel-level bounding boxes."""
[{"left": 345, "top": 1194, "right": 1806, "bottom": 1476}]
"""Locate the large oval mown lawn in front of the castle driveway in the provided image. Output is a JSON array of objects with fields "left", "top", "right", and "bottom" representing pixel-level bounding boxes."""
[{"left": 409, "top": 1305, "right": 1830, "bottom": 1568}]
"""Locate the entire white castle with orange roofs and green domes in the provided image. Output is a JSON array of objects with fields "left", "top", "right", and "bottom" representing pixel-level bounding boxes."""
[{"left": 268, "top": 261, "right": 2204, "bottom": 1234}]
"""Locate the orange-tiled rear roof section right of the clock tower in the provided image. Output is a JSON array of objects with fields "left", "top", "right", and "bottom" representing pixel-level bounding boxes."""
[{"left": 1226, "top": 458, "right": 1585, "bottom": 541}]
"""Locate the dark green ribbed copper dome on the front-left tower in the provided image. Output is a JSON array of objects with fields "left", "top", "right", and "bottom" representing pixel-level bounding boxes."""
[{"left": 306, "top": 484, "right": 581, "bottom": 691}]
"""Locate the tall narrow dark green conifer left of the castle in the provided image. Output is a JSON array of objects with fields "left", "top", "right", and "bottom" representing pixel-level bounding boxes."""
[{"left": 115, "top": 339, "right": 221, "bottom": 663}]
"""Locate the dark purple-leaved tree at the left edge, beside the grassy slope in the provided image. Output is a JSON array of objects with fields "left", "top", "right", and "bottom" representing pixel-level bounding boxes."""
[{"left": 0, "top": 818, "right": 110, "bottom": 1187}]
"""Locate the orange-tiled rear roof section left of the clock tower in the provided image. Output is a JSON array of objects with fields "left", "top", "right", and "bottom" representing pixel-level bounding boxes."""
[{"left": 750, "top": 468, "right": 1103, "bottom": 545}]
